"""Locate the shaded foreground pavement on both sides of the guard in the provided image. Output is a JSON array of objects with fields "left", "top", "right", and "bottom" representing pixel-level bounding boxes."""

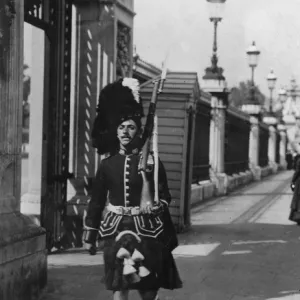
[{"left": 41, "top": 224, "right": 300, "bottom": 300}]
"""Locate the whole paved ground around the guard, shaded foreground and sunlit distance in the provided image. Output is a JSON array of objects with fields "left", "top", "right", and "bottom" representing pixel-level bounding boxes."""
[{"left": 42, "top": 171, "right": 300, "bottom": 300}]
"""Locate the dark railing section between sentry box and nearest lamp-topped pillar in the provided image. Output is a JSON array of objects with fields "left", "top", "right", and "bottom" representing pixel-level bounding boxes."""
[{"left": 193, "top": 102, "right": 211, "bottom": 183}]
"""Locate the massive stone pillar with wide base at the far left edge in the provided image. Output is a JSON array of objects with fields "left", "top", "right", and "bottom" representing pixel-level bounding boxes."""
[{"left": 0, "top": 0, "right": 47, "bottom": 300}]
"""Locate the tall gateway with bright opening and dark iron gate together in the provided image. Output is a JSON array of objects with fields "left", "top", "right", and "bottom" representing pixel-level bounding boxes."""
[{"left": 21, "top": 0, "right": 72, "bottom": 251}]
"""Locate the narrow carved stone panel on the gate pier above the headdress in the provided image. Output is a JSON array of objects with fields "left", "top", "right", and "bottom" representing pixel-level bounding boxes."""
[{"left": 117, "top": 23, "right": 131, "bottom": 77}]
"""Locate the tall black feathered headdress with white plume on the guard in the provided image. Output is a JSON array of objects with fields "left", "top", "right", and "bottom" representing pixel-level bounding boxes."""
[{"left": 92, "top": 78, "right": 144, "bottom": 154}]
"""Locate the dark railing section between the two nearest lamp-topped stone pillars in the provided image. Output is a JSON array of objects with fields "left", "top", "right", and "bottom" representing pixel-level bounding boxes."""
[{"left": 224, "top": 110, "right": 251, "bottom": 175}]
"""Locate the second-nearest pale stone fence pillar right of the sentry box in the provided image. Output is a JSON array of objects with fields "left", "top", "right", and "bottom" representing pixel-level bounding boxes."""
[{"left": 249, "top": 117, "right": 261, "bottom": 180}]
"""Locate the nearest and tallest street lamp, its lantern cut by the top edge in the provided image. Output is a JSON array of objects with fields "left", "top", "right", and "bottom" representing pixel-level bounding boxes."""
[{"left": 203, "top": 0, "right": 226, "bottom": 81}]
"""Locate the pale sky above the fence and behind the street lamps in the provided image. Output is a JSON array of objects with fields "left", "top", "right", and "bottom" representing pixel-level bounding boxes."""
[{"left": 134, "top": 0, "right": 300, "bottom": 95}]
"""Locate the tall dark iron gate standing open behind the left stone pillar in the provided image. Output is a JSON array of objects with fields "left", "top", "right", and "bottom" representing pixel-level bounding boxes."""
[{"left": 24, "top": 0, "right": 72, "bottom": 250}]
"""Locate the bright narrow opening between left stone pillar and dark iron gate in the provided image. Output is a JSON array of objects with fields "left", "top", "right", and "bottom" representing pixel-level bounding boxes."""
[{"left": 21, "top": 23, "right": 47, "bottom": 225}]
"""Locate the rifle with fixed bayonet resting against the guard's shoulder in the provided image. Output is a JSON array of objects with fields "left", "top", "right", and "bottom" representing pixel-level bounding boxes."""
[{"left": 139, "top": 63, "right": 167, "bottom": 207}]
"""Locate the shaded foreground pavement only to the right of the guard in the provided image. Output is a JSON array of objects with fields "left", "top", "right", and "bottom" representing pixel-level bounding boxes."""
[{"left": 170, "top": 224, "right": 300, "bottom": 300}]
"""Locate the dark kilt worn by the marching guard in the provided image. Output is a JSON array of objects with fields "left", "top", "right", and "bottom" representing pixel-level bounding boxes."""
[{"left": 102, "top": 216, "right": 182, "bottom": 291}]
